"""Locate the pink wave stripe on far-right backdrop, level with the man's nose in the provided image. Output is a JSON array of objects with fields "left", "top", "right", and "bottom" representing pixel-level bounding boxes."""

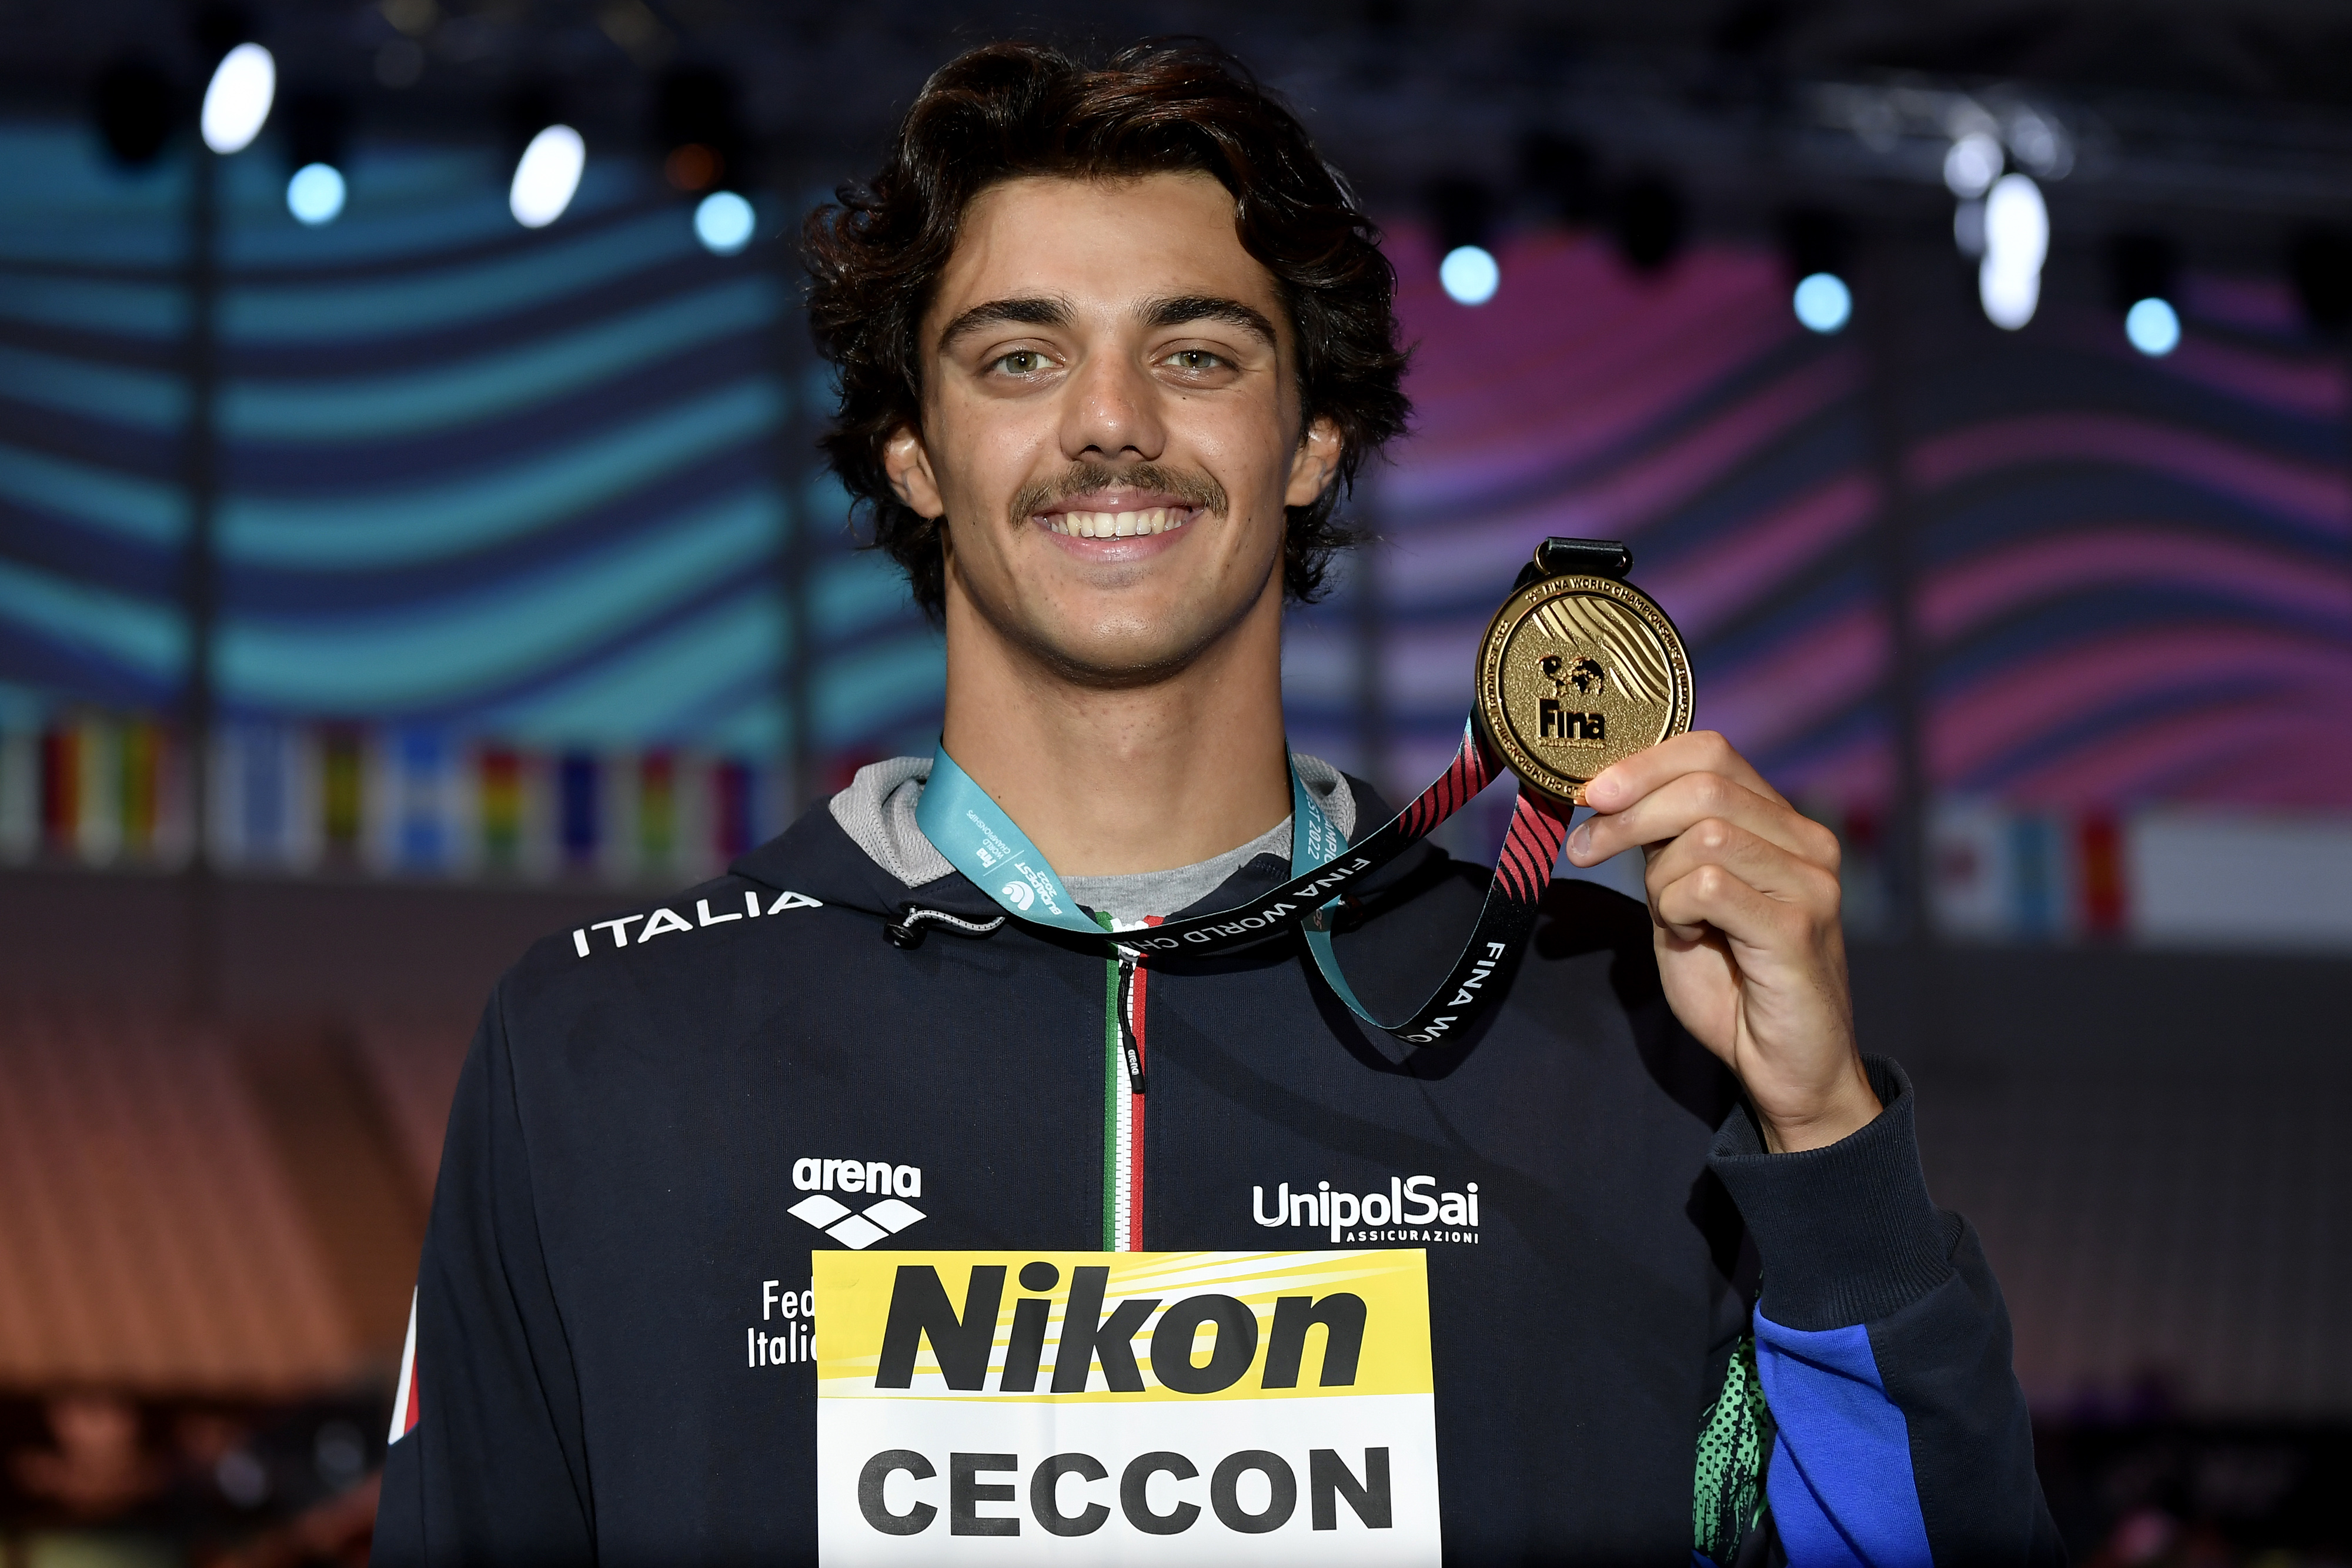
[{"left": 1903, "top": 414, "right": 2352, "bottom": 534}]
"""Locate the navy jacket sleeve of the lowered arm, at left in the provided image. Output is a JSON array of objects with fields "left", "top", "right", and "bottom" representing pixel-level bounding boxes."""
[{"left": 372, "top": 994, "right": 595, "bottom": 1568}]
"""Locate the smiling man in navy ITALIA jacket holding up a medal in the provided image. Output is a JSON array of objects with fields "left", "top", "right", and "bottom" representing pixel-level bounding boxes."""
[{"left": 379, "top": 47, "right": 2056, "bottom": 1563}]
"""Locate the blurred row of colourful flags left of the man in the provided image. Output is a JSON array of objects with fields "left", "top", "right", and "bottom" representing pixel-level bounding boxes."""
[{"left": 0, "top": 710, "right": 790, "bottom": 884}]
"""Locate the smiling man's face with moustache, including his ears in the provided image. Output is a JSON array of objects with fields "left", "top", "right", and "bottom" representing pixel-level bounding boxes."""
[{"left": 889, "top": 174, "right": 1338, "bottom": 684}]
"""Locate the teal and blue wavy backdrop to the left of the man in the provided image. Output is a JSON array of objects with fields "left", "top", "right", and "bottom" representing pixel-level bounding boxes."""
[{"left": 0, "top": 127, "right": 936, "bottom": 755}]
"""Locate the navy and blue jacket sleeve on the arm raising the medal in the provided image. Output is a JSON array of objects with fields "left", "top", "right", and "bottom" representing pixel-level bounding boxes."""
[{"left": 1710, "top": 1058, "right": 2065, "bottom": 1568}]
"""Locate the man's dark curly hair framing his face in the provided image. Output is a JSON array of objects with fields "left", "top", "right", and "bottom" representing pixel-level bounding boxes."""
[{"left": 802, "top": 40, "right": 1409, "bottom": 621}]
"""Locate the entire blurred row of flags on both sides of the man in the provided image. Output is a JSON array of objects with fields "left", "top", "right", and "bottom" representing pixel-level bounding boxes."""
[{"left": 0, "top": 710, "right": 2352, "bottom": 952}]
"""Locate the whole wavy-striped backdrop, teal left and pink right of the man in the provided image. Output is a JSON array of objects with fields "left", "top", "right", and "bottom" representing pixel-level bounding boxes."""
[{"left": 0, "top": 127, "right": 2352, "bottom": 832}]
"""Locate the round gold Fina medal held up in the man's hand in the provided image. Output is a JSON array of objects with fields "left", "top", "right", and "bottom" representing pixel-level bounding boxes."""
[{"left": 1475, "top": 541, "right": 1691, "bottom": 806}]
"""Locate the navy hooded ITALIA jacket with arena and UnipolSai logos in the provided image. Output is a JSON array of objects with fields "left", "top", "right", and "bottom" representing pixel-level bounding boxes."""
[{"left": 376, "top": 760, "right": 2060, "bottom": 1568}]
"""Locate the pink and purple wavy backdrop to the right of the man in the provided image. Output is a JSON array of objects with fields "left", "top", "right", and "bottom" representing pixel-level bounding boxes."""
[{"left": 1294, "top": 230, "right": 2352, "bottom": 811}]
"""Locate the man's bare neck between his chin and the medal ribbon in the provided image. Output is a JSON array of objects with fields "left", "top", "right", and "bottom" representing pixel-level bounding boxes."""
[{"left": 943, "top": 592, "right": 1291, "bottom": 877}]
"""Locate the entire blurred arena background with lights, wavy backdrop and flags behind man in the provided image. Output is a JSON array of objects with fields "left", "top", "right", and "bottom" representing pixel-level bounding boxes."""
[{"left": 0, "top": 0, "right": 2352, "bottom": 1566}]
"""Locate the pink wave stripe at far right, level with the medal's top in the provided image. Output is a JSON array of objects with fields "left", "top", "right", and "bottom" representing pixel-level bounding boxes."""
[{"left": 1919, "top": 524, "right": 2352, "bottom": 644}]
